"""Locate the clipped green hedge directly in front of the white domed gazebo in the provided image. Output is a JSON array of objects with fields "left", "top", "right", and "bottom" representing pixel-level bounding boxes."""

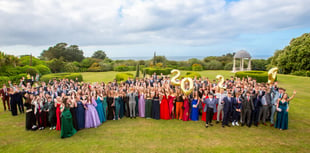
[{"left": 235, "top": 71, "right": 277, "bottom": 82}]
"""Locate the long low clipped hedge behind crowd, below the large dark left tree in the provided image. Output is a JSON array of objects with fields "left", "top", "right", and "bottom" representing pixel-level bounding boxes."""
[{"left": 40, "top": 73, "right": 83, "bottom": 82}]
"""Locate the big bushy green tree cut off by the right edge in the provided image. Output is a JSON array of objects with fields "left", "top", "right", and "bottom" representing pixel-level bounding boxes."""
[{"left": 269, "top": 33, "right": 310, "bottom": 74}]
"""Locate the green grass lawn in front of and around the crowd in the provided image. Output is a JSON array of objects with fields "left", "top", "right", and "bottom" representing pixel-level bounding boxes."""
[{"left": 0, "top": 71, "right": 310, "bottom": 153}]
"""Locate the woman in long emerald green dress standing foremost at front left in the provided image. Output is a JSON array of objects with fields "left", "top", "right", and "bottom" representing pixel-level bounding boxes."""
[{"left": 60, "top": 98, "right": 76, "bottom": 138}]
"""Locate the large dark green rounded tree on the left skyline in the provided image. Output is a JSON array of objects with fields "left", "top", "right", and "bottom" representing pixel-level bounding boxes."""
[{"left": 40, "top": 43, "right": 84, "bottom": 62}]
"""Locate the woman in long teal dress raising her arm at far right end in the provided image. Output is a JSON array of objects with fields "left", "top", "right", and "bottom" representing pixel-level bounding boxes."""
[{"left": 275, "top": 91, "right": 296, "bottom": 130}]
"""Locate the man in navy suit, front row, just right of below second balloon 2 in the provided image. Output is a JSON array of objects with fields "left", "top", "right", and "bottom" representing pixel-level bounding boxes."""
[{"left": 222, "top": 91, "right": 235, "bottom": 128}]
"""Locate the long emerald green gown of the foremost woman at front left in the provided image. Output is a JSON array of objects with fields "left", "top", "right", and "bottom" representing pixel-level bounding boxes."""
[{"left": 60, "top": 107, "right": 76, "bottom": 138}]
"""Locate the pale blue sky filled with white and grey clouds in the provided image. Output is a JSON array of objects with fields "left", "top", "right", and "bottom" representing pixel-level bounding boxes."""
[{"left": 0, "top": 0, "right": 310, "bottom": 57}]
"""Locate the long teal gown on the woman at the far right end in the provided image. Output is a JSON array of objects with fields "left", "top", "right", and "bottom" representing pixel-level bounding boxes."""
[{"left": 275, "top": 101, "right": 288, "bottom": 130}]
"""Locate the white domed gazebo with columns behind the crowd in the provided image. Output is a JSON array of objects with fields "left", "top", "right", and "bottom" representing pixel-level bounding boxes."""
[{"left": 233, "top": 50, "right": 251, "bottom": 72}]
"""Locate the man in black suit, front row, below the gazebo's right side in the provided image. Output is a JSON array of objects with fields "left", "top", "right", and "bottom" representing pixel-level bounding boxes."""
[{"left": 242, "top": 92, "right": 254, "bottom": 127}]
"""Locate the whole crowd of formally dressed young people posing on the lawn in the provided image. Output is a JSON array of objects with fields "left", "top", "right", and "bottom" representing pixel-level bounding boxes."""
[{"left": 0, "top": 73, "right": 296, "bottom": 138}]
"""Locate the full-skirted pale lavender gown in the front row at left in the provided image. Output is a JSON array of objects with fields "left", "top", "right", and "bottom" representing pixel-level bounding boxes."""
[{"left": 85, "top": 100, "right": 100, "bottom": 128}]
